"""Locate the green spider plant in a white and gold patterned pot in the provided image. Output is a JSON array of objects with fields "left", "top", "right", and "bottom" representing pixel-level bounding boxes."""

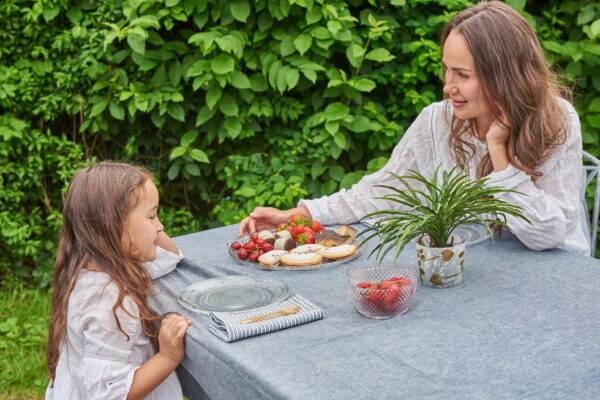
[{"left": 360, "top": 166, "right": 531, "bottom": 287}]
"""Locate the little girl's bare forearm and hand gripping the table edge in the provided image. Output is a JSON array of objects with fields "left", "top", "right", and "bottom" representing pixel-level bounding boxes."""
[{"left": 127, "top": 315, "right": 191, "bottom": 400}]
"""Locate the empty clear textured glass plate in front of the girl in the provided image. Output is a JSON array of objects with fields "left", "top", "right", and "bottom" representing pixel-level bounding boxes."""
[{"left": 179, "top": 275, "right": 289, "bottom": 314}]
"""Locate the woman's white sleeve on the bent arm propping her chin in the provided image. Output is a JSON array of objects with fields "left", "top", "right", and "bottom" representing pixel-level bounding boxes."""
[{"left": 488, "top": 102, "right": 589, "bottom": 254}]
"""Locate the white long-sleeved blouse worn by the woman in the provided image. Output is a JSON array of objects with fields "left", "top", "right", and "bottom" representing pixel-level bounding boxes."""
[{"left": 298, "top": 99, "right": 590, "bottom": 255}]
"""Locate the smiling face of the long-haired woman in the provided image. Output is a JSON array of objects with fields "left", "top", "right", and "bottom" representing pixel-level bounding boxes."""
[{"left": 442, "top": 30, "right": 493, "bottom": 134}]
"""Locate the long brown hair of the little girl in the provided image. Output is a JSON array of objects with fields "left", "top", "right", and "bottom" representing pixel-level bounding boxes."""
[{"left": 46, "top": 162, "right": 158, "bottom": 379}]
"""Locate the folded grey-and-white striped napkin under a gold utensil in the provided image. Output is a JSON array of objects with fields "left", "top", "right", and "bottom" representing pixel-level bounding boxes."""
[{"left": 208, "top": 296, "right": 323, "bottom": 342}]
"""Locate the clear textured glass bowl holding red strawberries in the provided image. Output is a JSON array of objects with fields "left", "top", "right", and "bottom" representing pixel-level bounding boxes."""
[{"left": 346, "top": 267, "right": 417, "bottom": 319}]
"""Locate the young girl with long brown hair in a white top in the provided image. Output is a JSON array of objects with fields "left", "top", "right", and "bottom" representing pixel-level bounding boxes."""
[{"left": 46, "top": 162, "right": 190, "bottom": 400}]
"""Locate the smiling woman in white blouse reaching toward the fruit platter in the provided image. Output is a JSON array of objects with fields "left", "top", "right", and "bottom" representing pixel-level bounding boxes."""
[{"left": 239, "top": 1, "right": 590, "bottom": 254}]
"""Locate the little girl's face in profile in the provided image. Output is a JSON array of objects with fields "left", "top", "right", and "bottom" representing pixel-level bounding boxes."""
[{"left": 123, "top": 179, "right": 164, "bottom": 261}]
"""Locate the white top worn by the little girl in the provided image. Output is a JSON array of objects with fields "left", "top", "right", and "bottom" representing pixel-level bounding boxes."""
[{"left": 46, "top": 247, "right": 183, "bottom": 400}]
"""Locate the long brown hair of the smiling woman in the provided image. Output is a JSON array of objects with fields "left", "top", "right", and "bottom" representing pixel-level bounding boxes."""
[{"left": 441, "top": 1, "right": 571, "bottom": 178}]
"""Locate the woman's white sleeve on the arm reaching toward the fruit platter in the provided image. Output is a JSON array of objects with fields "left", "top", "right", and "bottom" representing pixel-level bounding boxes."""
[{"left": 298, "top": 105, "right": 434, "bottom": 225}]
